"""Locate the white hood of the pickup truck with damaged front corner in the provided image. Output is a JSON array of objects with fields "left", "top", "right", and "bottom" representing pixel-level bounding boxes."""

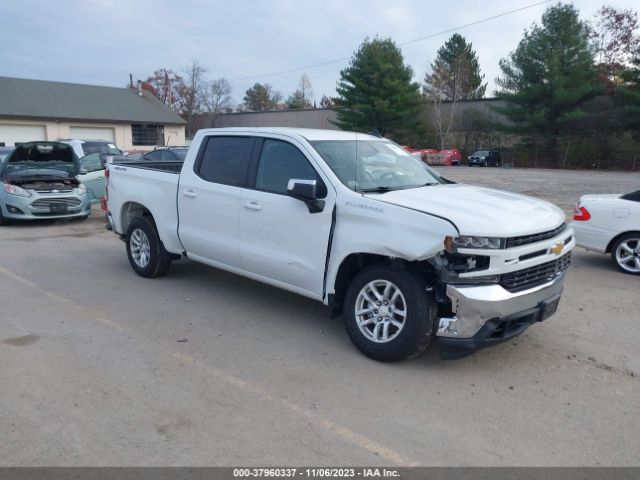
[{"left": 364, "top": 184, "right": 565, "bottom": 237}]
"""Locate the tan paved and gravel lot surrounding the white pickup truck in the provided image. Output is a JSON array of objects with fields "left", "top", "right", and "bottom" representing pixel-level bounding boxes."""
[{"left": 0, "top": 167, "right": 640, "bottom": 466}]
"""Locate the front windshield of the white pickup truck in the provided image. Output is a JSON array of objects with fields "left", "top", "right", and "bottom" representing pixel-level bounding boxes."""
[{"left": 311, "top": 140, "right": 443, "bottom": 191}]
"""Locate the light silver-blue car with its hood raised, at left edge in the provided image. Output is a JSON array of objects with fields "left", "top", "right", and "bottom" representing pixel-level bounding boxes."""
[{"left": 0, "top": 142, "right": 91, "bottom": 224}]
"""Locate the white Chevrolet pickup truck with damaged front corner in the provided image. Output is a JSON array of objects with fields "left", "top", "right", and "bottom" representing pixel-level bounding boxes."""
[{"left": 107, "top": 128, "right": 575, "bottom": 361}]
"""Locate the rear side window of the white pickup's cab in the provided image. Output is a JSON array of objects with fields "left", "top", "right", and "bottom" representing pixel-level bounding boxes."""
[{"left": 196, "top": 136, "right": 254, "bottom": 187}]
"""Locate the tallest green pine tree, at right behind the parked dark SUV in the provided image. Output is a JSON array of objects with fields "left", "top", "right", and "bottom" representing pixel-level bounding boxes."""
[{"left": 496, "top": 4, "right": 600, "bottom": 166}]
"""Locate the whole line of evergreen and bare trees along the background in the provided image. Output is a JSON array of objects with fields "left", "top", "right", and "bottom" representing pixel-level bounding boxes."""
[{"left": 143, "top": 3, "right": 640, "bottom": 168}]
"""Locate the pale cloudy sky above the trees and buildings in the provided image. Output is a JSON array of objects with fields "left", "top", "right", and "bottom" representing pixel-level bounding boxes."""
[{"left": 0, "top": 0, "right": 637, "bottom": 104}]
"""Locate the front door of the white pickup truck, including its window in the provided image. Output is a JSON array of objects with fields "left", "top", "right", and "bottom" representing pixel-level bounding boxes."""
[{"left": 240, "top": 137, "right": 336, "bottom": 297}]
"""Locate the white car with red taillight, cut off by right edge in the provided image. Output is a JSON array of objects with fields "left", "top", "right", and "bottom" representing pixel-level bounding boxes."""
[{"left": 571, "top": 190, "right": 640, "bottom": 275}]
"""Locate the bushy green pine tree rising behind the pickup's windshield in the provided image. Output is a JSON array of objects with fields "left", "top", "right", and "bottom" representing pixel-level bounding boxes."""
[{"left": 333, "top": 38, "right": 422, "bottom": 141}]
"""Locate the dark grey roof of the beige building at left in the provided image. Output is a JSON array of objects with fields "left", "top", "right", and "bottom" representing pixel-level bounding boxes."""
[{"left": 0, "top": 77, "right": 185, "bottom": 125}]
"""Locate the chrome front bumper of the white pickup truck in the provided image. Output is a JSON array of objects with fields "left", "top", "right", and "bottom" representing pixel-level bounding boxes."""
[{"left": 436, "top": 274, "right": 565, "bottom": 339}]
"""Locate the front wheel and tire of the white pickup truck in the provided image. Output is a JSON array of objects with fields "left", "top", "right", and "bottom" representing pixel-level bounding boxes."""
[{"left": 343, "top": 264, "right": 437, "bottom": 362}]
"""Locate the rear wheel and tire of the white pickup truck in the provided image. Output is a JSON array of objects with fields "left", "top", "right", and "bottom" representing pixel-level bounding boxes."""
[{"left": 127, "top": 217, "right": 171, "bottom": 278}]
